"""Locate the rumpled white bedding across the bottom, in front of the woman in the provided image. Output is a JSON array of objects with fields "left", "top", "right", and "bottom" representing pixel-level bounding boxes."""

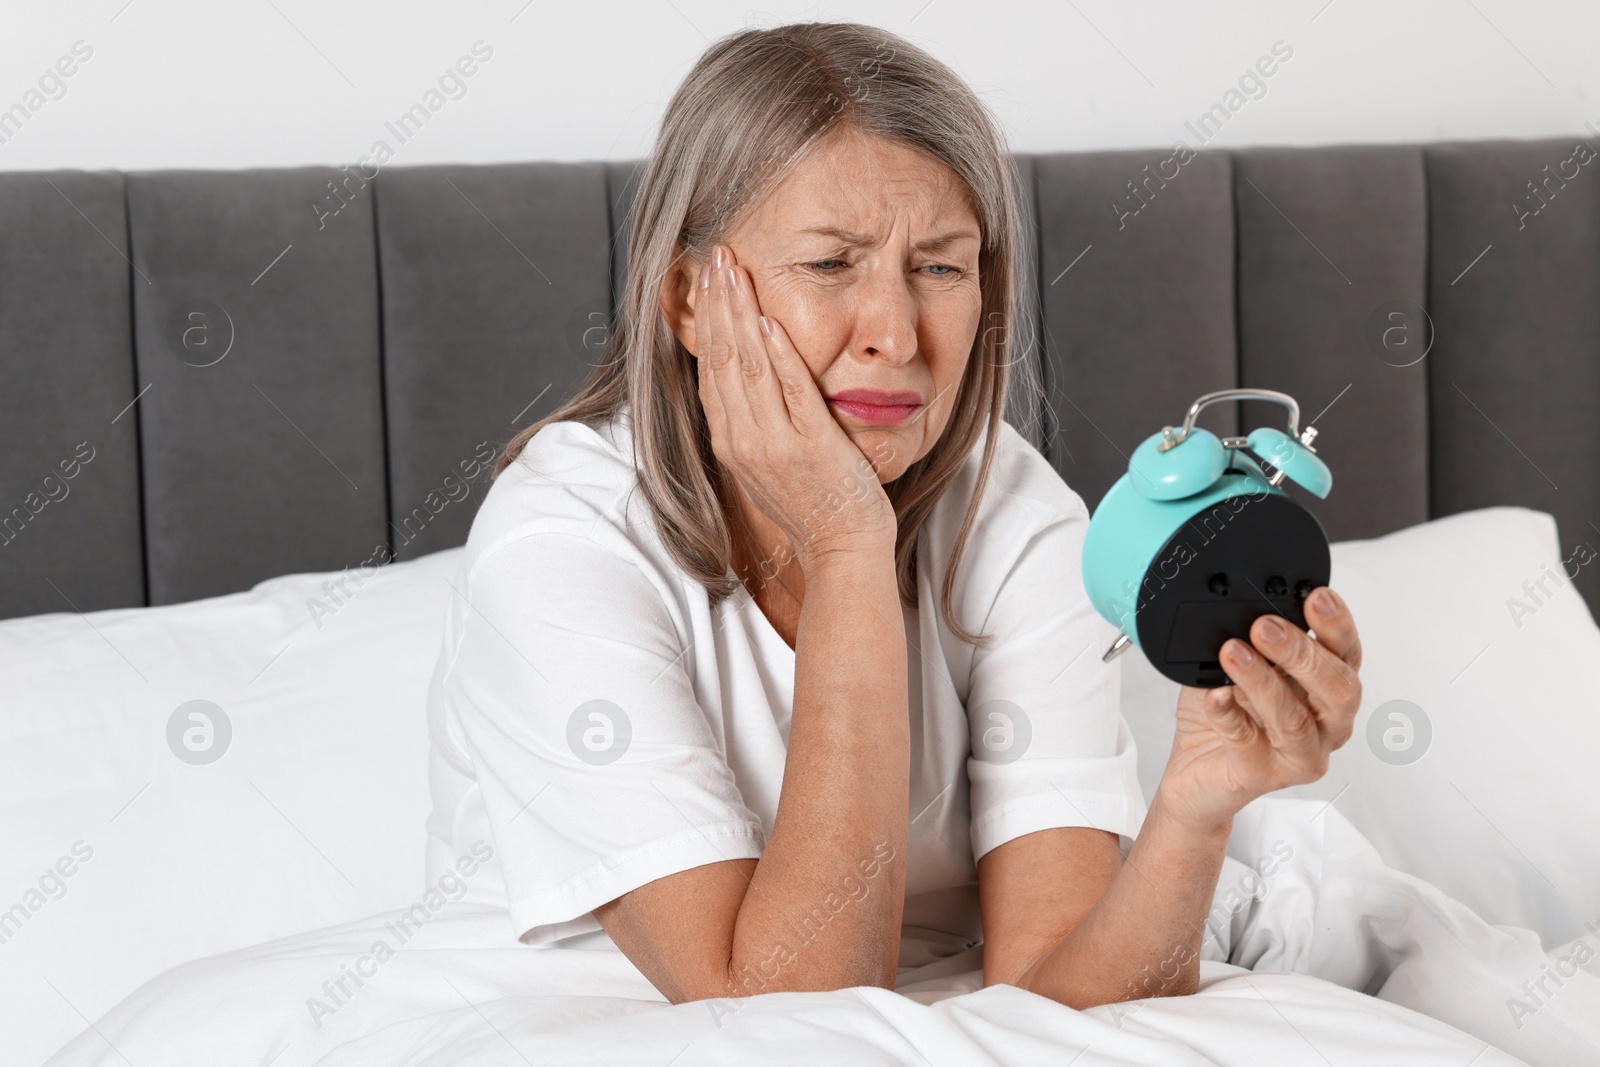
[{"left": 46, "top": 797, "right": 1600, "bottom": 1067}]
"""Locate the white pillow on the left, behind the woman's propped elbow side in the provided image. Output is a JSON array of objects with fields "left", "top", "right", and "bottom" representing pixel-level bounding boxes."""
[{"left": 0, "top": 549, "right": 461, "bottom": 1062}]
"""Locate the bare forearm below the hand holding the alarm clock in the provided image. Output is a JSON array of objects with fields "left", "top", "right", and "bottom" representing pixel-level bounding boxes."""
[{"left": 1016, "top": 790, "right": 1232, "bottom": 1009}]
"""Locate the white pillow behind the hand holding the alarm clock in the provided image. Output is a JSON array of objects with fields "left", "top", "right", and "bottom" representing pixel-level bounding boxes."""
[{"left": 1122, "top": 507, "right": 1600, "bottom": 947}]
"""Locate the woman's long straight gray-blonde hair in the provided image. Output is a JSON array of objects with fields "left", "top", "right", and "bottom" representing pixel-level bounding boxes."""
[{"left": 494, "top": 22, "right": 1043, "bottom": 643}]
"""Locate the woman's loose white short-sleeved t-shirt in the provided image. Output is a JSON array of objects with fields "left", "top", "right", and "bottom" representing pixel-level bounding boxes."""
[{"left": 427, "top": 413, "right": 1146, "bottom": 966}]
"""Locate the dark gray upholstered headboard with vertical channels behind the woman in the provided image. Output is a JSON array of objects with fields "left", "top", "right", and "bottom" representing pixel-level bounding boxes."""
[{"left": 0, "top": 139, "right": 1600, "bottom": 627}]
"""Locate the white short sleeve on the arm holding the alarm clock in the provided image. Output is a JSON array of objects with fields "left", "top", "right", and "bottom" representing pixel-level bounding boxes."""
[{"left": 966, "top": 495, "right": 1146, "bottom": 859}]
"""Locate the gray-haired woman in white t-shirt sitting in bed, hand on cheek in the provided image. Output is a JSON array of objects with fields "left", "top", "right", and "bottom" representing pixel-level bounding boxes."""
[{"left": 430, "top": 24, "right": 1362, "bottom": 1008}]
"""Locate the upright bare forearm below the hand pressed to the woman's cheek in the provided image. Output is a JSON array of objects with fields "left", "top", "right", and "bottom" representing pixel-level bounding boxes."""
[{"left": 731, "top": 547, "right": 910, "bottom": 995}]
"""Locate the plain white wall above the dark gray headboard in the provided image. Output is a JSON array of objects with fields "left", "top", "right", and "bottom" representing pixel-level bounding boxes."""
[{"left": 0, "top": 0, "right": 1600, "bottom": 170}]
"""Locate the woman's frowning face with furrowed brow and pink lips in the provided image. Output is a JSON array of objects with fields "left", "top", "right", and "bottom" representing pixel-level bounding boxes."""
[{"left": 668, "top": 128, "right": 982, "bottom": 482}]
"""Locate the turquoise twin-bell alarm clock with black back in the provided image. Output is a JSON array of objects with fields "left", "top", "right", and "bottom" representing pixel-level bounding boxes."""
[{"left": 1083, "top": 389, "right": 1333, "bottom": 686}]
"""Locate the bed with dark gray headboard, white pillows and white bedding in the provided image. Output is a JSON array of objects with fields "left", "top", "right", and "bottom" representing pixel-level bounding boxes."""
[{"left": 0, "top": 141, "right": 1600, "bottom": 1067}]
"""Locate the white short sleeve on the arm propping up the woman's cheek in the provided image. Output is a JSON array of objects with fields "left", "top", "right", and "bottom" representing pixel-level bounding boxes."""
[{"left": 445, "top": 533, "right": 763, "bottom": 944}]
